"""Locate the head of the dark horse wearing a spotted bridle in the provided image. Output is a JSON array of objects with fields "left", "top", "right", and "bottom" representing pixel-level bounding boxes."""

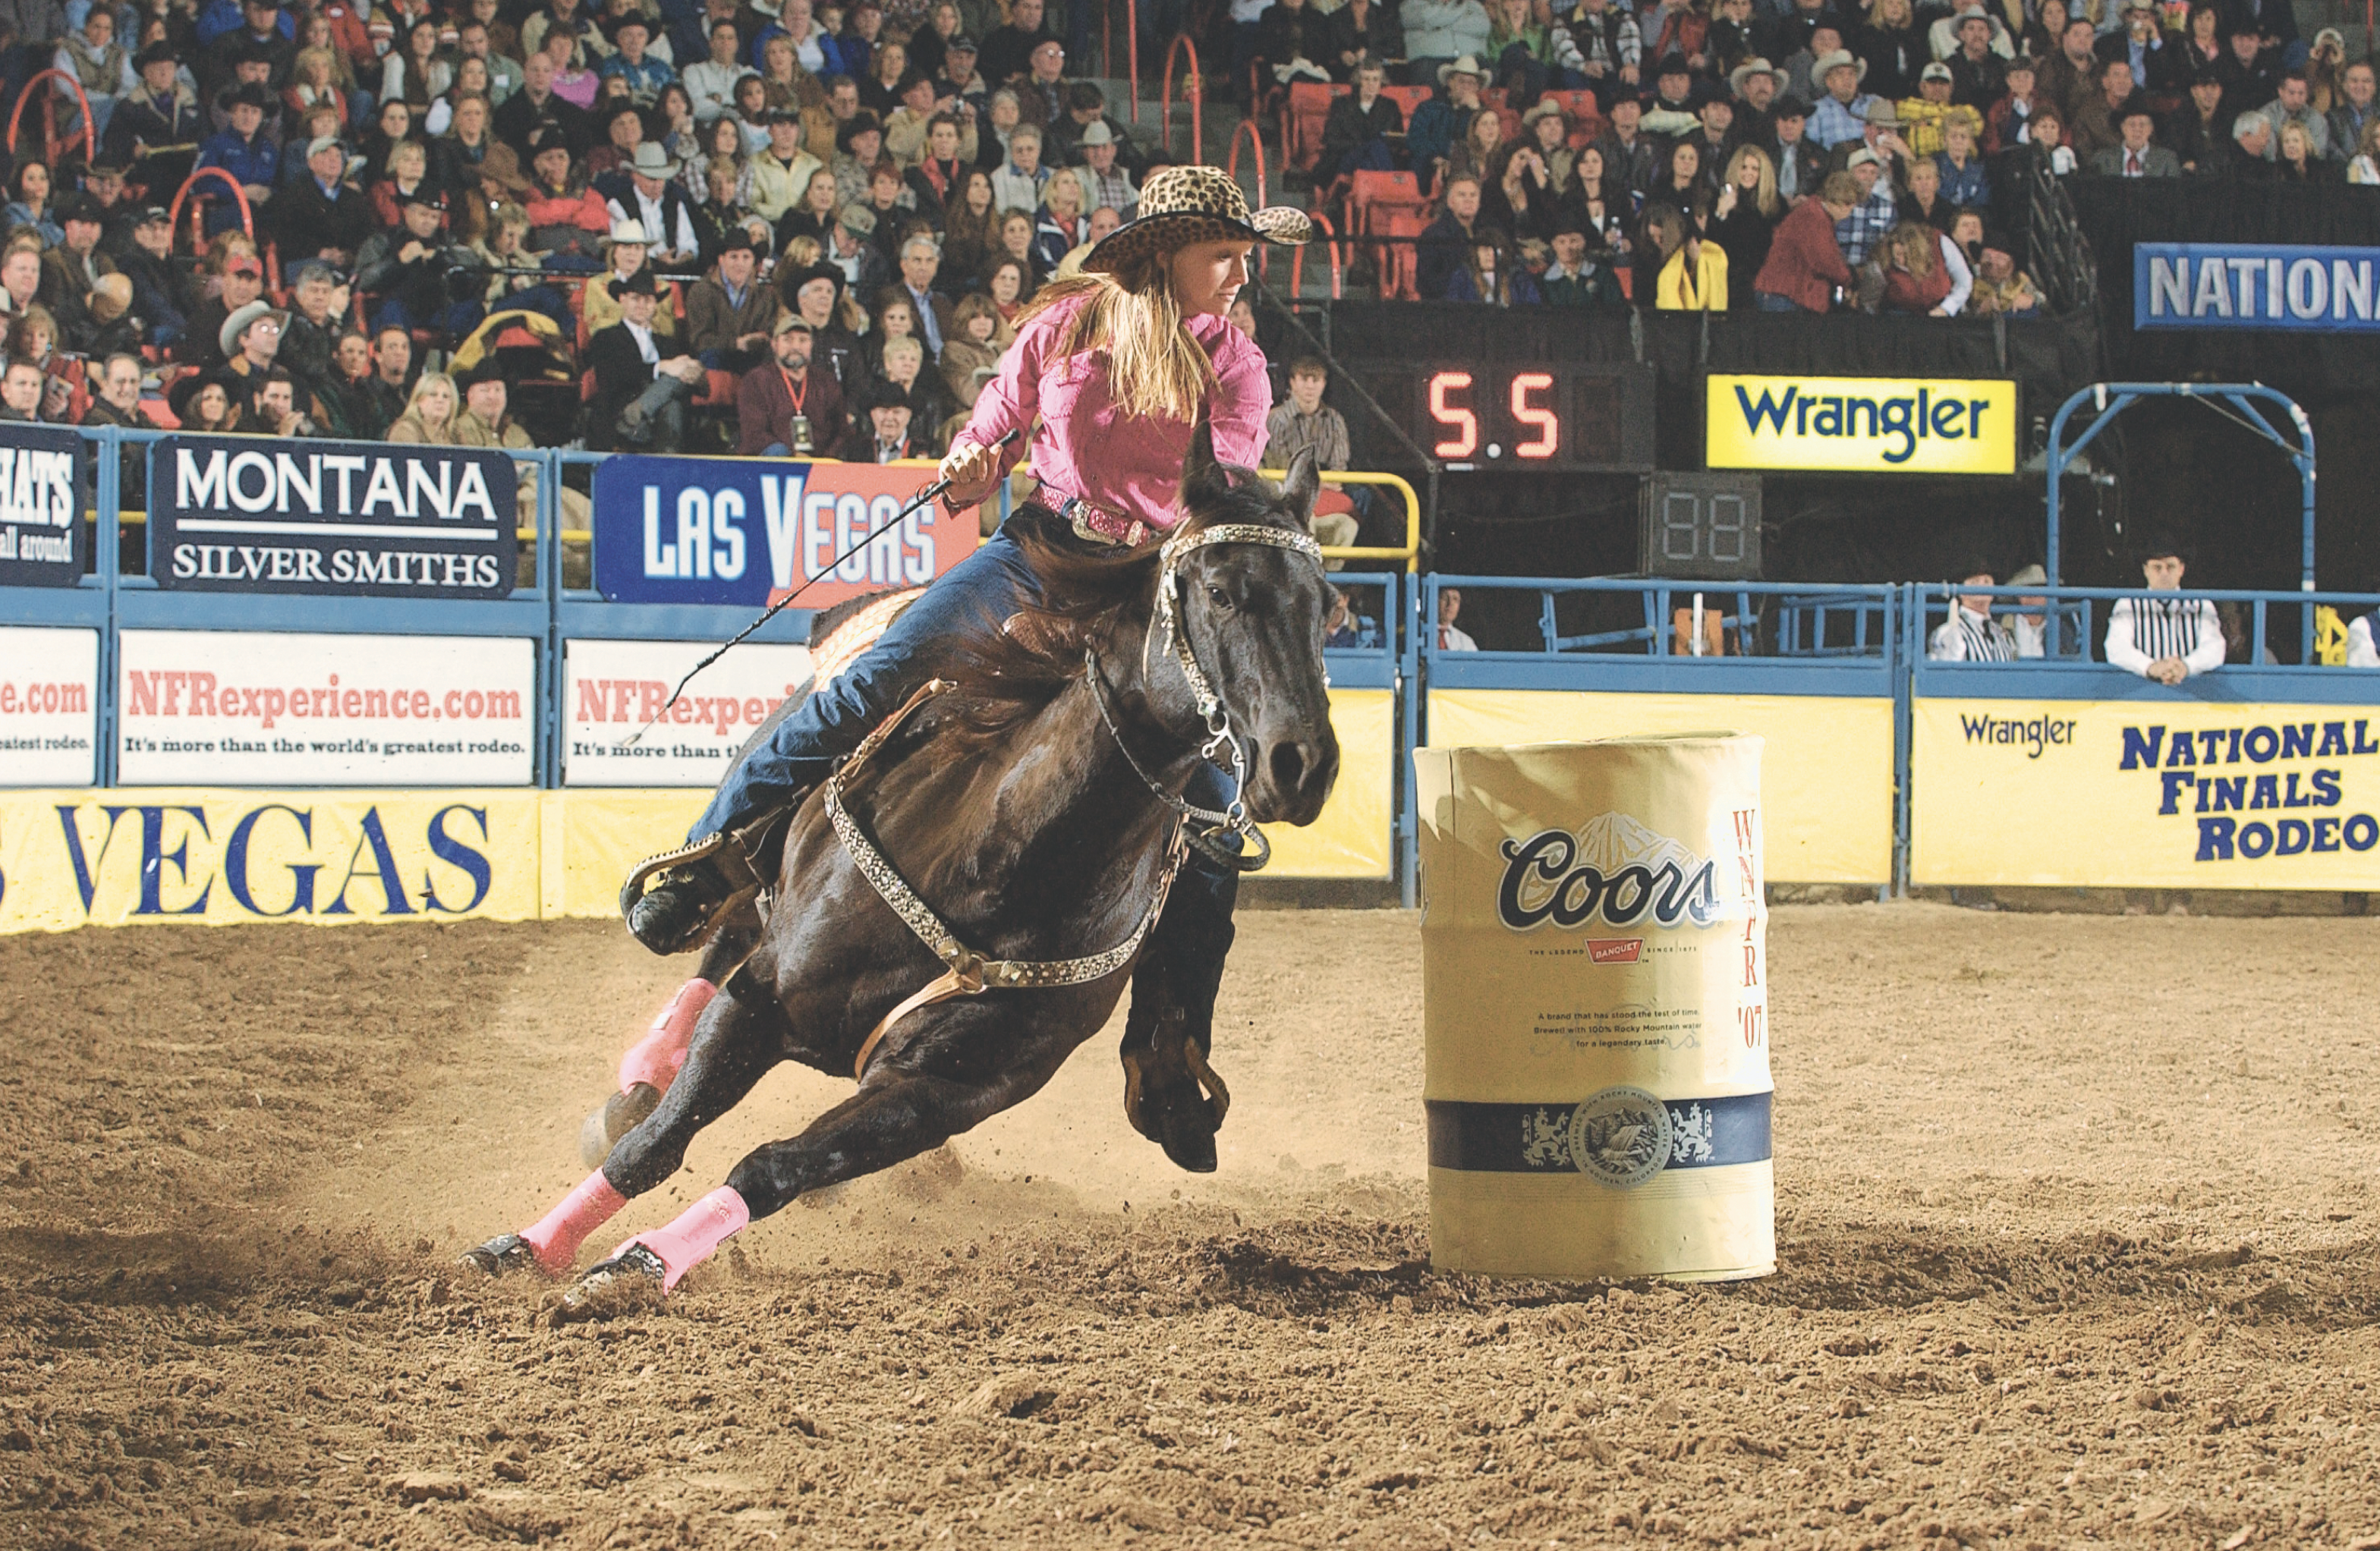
[{"left": 1166, "top": 423, "right": 1337, "bottom": 823}]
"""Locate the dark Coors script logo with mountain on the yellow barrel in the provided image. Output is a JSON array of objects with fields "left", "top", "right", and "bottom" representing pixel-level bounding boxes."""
[{"left": 1494, "top": 813, "right": 1718, "bottom": 933}]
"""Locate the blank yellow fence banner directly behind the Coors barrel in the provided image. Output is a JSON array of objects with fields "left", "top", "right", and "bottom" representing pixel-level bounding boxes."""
[{"left": 1431, "top": 690, "right": 1892, "bottom": 882}]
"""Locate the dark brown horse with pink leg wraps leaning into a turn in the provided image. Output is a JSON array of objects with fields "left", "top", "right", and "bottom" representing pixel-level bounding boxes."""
[{"left": 467, "top": 430, "right": 1337, "bottom": 1306}]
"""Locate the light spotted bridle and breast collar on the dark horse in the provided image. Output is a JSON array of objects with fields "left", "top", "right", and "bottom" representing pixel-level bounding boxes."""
[{"left": 823, "top": 524, "right": 1321, "bottom": 1080}]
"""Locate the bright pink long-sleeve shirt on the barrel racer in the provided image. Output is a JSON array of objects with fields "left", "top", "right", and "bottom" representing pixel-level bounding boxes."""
[{"left": 952, "top": 297, "right": 1273, "bottom": 533}]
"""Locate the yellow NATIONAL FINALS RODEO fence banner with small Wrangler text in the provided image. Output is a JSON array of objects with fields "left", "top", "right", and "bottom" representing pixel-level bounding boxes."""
[{"left": 1909, "top": 700, "right": 2380, "bottom": 889}]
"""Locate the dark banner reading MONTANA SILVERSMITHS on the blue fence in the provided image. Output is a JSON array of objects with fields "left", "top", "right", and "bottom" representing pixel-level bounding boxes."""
[{"left": 150, "top": 436, "right": 519, "bottom": 597}]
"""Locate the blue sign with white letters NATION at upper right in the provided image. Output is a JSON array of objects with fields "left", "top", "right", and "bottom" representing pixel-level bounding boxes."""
[{"left": 2133, "top": 243, "right": 2380, "bottom": 333}]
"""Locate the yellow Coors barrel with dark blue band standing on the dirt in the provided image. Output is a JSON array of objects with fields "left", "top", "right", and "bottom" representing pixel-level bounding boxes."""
[{"left": 1414, "top": 733, "right": 1775, "bottom": 1280}]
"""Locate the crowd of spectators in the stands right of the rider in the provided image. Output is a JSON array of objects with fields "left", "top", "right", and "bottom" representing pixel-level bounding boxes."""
[{"left": 1304, "top": 0, "right": 2380, "bottom": 316}]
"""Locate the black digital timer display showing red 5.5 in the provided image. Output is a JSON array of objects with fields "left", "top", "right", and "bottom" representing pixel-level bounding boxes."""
[{"left": 1354, "top": 359, "right": 1654, "bottom": 473}]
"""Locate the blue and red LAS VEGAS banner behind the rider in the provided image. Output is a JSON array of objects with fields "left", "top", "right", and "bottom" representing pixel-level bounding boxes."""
[{"left": 595, "top": 457, "right": 983, "bottom": 609}]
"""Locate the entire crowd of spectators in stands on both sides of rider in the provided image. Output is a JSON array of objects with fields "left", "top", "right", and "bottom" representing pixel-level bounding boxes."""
[{"left": 0, "top": 0, "right": 2380, "bottom": 461}]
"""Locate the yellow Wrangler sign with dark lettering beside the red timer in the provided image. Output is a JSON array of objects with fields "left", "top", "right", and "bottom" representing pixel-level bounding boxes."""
[{"left": 1704, "top": 371, "right": 2016, "bottom": 473}]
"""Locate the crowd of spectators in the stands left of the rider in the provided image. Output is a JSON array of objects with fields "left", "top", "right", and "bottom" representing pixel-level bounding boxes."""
[{"left": 0, "top": 0, "right": 1199, "bottom": 461}]
